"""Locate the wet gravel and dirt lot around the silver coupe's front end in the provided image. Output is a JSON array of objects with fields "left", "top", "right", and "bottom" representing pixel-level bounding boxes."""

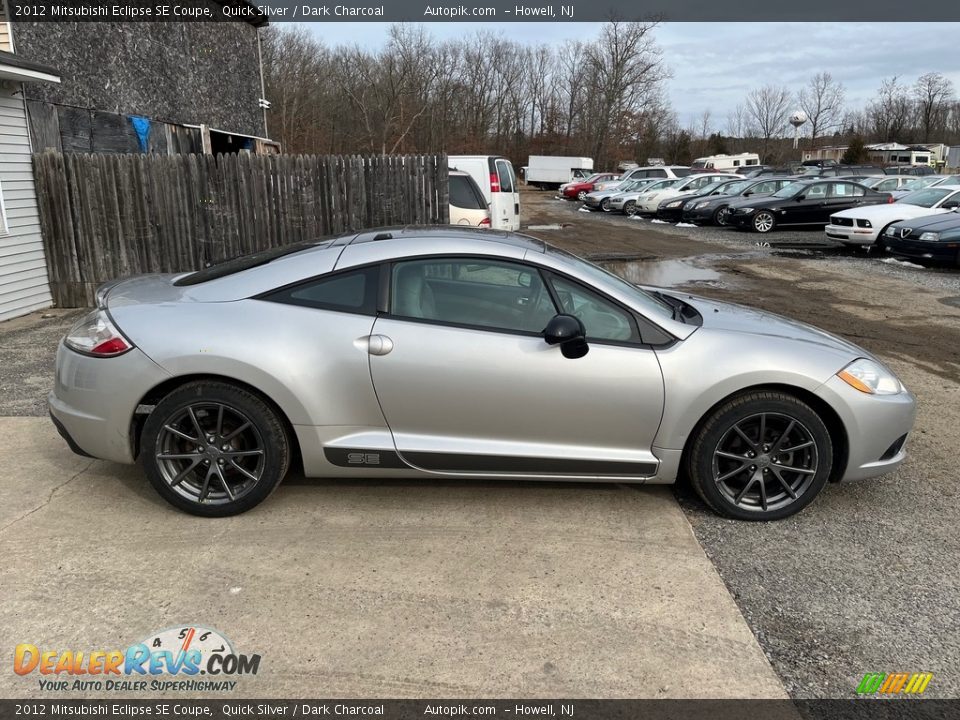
[{"left": 524, "top": 188, "right": 960, "bottom": 698}]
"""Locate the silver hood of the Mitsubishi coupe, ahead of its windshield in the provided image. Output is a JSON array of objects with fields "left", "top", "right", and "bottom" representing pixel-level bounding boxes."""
[{"left": 677, "top": 295, "right": 875, "bottom": 360}]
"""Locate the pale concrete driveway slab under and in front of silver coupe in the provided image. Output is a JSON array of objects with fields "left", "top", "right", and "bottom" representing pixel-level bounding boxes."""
[{"left": 0, "top": 417, "right": 785, "bottom": 698}]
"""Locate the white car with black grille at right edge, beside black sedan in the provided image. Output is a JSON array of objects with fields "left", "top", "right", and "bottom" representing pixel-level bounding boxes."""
[{"left": 825, "top": 185, "right": 960, "bottom": 245}]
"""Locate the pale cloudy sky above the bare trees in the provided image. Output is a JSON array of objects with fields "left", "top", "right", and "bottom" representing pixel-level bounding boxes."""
[{"left": 304, "top": 22, "right": 960, "bottom": 130}]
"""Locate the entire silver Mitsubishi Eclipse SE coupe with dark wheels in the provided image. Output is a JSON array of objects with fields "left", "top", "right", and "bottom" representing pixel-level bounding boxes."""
[{"left": 49, "top": 227, "right": 915, "bottom": 520}]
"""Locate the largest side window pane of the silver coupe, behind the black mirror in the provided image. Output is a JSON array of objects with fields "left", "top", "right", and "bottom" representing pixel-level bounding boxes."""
[{"left": 390, "top": 257, "right": 557, "bottom": 333}]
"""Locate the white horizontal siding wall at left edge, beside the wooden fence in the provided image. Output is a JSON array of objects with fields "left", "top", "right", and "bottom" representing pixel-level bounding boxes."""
[{"left": 0, "top": 83, "right": 51, "bottom": 321}]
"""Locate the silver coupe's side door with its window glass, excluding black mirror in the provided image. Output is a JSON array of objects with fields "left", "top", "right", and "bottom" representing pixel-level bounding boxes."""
[{"left": 370, "top": 256, "right": 663, "bottom": 478}]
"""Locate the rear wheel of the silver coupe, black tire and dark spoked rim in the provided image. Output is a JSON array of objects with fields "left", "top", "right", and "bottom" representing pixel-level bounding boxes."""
[{"left": 140, "top": 381, "right": 290, "bottom": 517}]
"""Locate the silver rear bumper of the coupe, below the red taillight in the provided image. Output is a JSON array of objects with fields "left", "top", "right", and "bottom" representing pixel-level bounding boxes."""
[{"left": 47, "top": 342, "right": 170, "bottom": 463}]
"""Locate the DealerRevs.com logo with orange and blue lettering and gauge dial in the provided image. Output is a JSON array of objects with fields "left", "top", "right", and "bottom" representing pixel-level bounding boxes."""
[{"left": 13, "top": 625, "right": 260, "bottom": 692}]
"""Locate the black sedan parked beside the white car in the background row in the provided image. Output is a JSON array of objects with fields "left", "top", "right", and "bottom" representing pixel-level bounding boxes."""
[{"left": 727, "top": 178, "right": 893, "bottom": 233}]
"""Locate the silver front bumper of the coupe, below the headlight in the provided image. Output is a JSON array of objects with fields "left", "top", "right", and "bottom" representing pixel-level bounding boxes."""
[{"left": 816, "top": 376, "right": 917, "bottom": 480}]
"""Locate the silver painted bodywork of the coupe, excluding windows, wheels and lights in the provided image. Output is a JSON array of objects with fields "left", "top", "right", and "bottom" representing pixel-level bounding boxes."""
[{"left": 49, "top": 227, "right": 915, "bottom": 490}]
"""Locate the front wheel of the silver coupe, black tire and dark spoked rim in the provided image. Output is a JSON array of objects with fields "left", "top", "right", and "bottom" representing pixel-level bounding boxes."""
[{"left": 686, "top": 392, "right": 833, "bottom": 520}]
